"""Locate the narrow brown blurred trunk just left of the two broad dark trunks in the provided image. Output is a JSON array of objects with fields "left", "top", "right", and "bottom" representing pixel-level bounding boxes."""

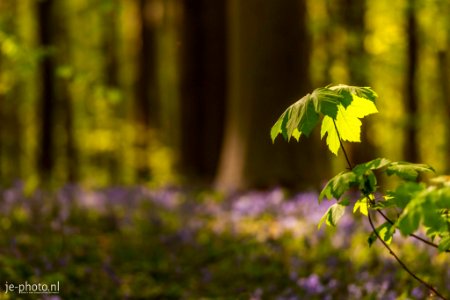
[{"left": 134, "top": 0, "right": 160, "bottom": 181}]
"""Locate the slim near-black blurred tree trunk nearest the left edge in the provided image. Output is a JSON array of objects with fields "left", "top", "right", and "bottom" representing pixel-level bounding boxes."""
[{"left": 37, "top": 0, "right": 56, "bottom": 181}]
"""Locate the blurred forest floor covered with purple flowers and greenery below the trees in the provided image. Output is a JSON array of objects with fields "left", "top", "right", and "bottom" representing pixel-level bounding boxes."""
[{"left": 0, "top": 183, "right": 450, "bottom": 300}]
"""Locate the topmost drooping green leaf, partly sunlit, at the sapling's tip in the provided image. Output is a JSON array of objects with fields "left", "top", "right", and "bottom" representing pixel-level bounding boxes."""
[{"left": 270, "top": 84, "right": 378, "bottom": 155}]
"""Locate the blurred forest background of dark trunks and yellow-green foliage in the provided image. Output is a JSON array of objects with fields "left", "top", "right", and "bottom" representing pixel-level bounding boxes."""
[{"left": 0, "top": 0, "right": 450, "bottom": 191}]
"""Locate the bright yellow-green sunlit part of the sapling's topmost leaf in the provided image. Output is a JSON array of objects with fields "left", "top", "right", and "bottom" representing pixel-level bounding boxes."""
[{"left": 320, "top": 94, "right": 378, "bottom": 155}]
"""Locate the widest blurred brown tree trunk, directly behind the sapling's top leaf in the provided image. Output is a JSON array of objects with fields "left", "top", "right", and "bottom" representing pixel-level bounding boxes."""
[{"left": 216, "top": 0, "right": 329, "bottom": 191}]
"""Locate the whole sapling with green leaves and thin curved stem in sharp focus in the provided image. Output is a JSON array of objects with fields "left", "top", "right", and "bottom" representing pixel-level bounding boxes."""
[{"left": 270, "top": 84, "right": 450, "bottom": 299}]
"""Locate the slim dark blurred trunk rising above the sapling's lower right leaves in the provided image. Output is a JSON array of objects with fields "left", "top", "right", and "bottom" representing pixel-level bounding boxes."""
[{"left": 403, "top": 0, "right": 419, "bottom": 162}]
